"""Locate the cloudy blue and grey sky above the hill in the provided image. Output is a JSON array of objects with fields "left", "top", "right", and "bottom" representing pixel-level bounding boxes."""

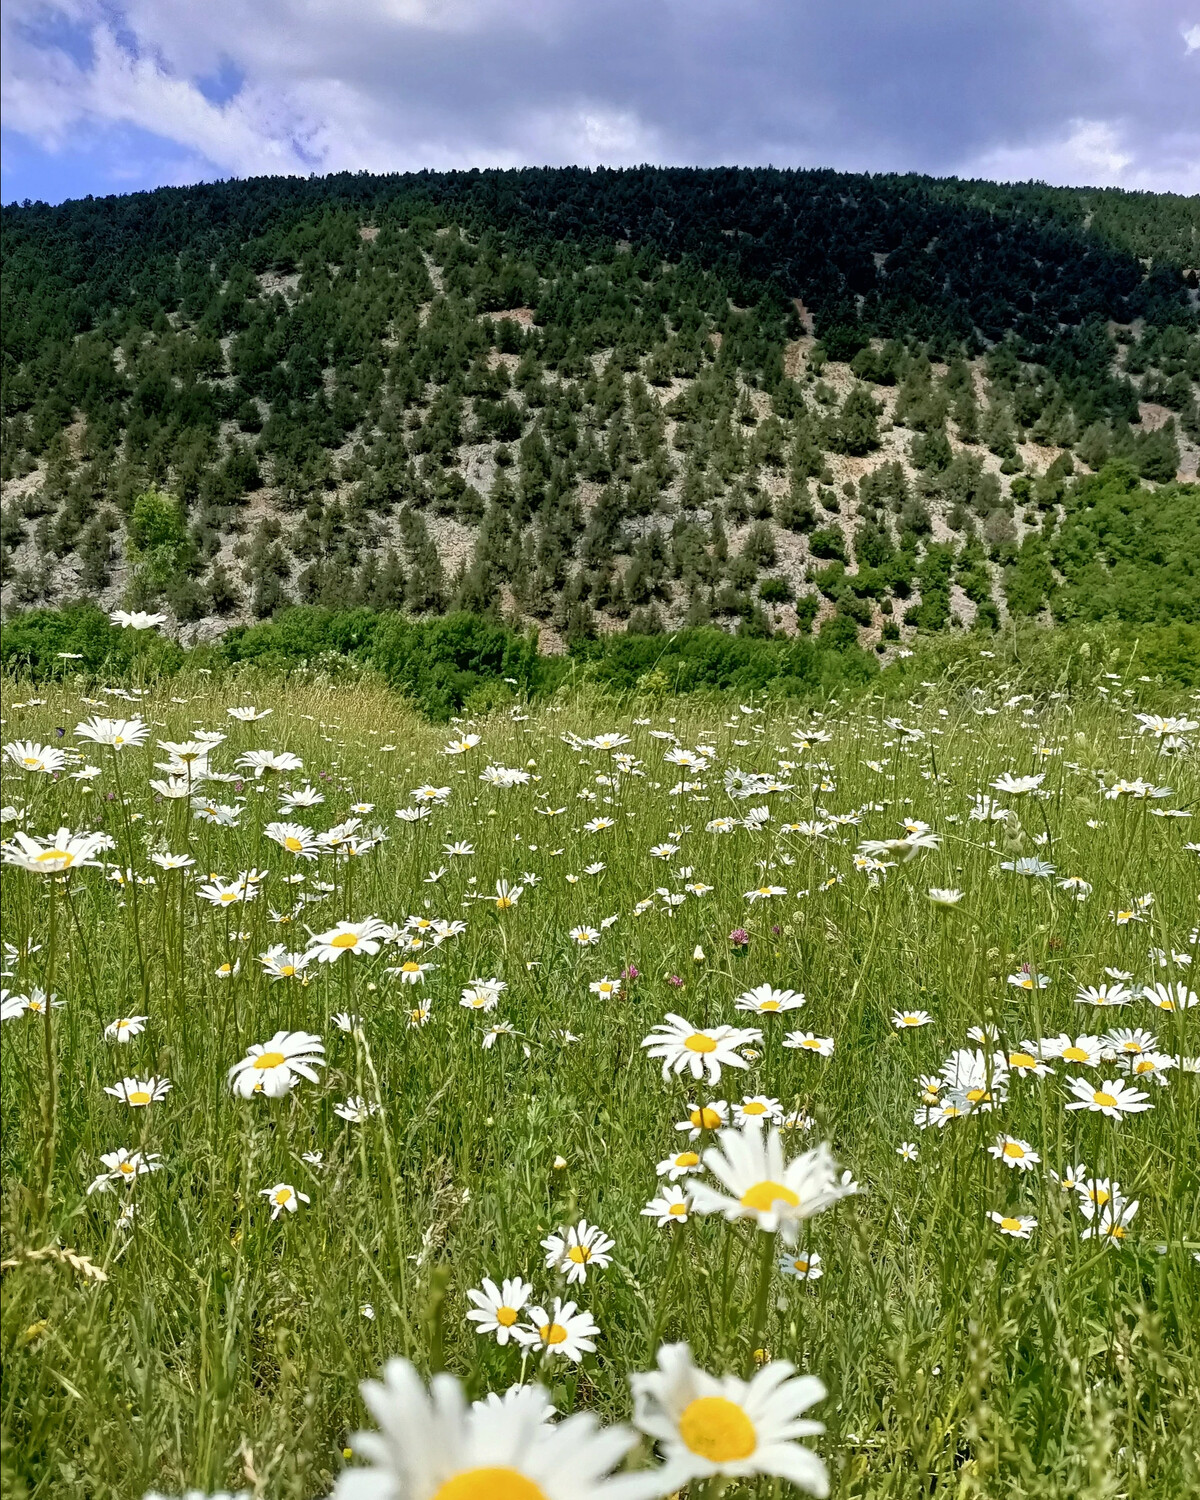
[{"left": 0, "top": 0, "right": 1200, "bottom": 203}]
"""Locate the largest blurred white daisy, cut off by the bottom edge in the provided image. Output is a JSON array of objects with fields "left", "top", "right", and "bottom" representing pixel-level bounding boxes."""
[{"left": 324, "top": 1356, "right": 633, "bottom": 1500}]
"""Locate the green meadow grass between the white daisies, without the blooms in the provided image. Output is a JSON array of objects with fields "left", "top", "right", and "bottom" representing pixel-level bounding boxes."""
[{"left": 2, "top": 663, "right": 1200, "bottom": 1500}]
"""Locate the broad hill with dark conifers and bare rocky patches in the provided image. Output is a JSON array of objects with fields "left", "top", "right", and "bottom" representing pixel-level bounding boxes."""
[{"left": 0, "top": 168, "right": 1200, "bottom": 645}]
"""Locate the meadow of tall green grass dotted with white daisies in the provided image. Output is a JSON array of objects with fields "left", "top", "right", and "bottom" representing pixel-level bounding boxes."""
[{"left": 2, "top": 663, "right": 1200, "bottom": 1500}]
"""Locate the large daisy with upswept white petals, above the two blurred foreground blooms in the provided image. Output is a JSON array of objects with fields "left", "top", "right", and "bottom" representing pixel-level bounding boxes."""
[{"left": 692, "top": 1128, "right": 848, "bottom": 1245}]
